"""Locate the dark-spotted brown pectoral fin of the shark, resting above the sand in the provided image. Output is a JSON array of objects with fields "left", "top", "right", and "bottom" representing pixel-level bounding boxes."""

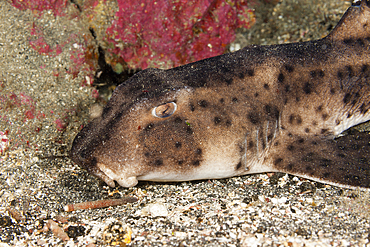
[{"left": 270, "top": 132, "right": 370, "bottom": 188}]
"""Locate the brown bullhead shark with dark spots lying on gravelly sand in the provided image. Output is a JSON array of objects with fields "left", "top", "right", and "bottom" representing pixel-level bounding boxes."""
[{"left": 70, "top": 0, "right": 370, "bottom": 188}]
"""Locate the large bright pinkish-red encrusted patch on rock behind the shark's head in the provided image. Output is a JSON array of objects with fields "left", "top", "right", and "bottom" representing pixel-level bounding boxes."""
[{"left": 107, "top": 0, "right": 254, "bottom": 69}]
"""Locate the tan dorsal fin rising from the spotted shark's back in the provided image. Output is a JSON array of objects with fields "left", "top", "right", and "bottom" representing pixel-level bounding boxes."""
[{"left": 326, "top": 0, "right": 370, "bottom": 40}]
